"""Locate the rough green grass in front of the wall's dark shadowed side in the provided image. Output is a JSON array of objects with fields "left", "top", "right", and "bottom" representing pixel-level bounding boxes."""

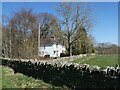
[{"left": 0, "top": 66, "right": 68, "bottom": 90}]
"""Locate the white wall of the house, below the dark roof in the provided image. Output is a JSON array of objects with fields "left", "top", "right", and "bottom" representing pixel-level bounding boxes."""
[{"left": 39, "top": 44, "right": 66, "bottom": 57}]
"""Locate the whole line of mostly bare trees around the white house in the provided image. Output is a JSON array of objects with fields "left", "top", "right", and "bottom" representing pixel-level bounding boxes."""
[{"left": 2, "top": 3, "right": 95, "bottom": 58}]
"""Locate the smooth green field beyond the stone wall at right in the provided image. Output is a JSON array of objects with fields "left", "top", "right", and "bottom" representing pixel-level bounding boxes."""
[{"left": 73, "top": 54, "right": 118, "bottom": 67}]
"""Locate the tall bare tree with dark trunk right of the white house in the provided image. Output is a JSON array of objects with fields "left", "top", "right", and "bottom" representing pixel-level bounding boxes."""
[{"left": 57, "top": 3, "right": 92, "bottom": 55}]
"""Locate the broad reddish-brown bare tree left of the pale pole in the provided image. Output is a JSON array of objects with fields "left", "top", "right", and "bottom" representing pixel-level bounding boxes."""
[{"left": 9, "top": 9, "right": 38, "bottom": 58}]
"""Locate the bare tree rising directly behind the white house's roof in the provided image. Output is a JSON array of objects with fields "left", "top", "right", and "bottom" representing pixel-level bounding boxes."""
[{"left": 38, "top": 12, "right": 59, "bottom": 38}]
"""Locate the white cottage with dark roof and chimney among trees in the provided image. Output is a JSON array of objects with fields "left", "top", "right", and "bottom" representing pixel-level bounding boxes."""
[{"left": 39, "top": 35, "right": 66, "bottom": 58}]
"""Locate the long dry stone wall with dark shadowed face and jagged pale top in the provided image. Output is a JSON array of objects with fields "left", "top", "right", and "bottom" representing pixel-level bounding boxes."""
[{"left": 0, "top": 58, "right": 120, "bottom": 90}]
